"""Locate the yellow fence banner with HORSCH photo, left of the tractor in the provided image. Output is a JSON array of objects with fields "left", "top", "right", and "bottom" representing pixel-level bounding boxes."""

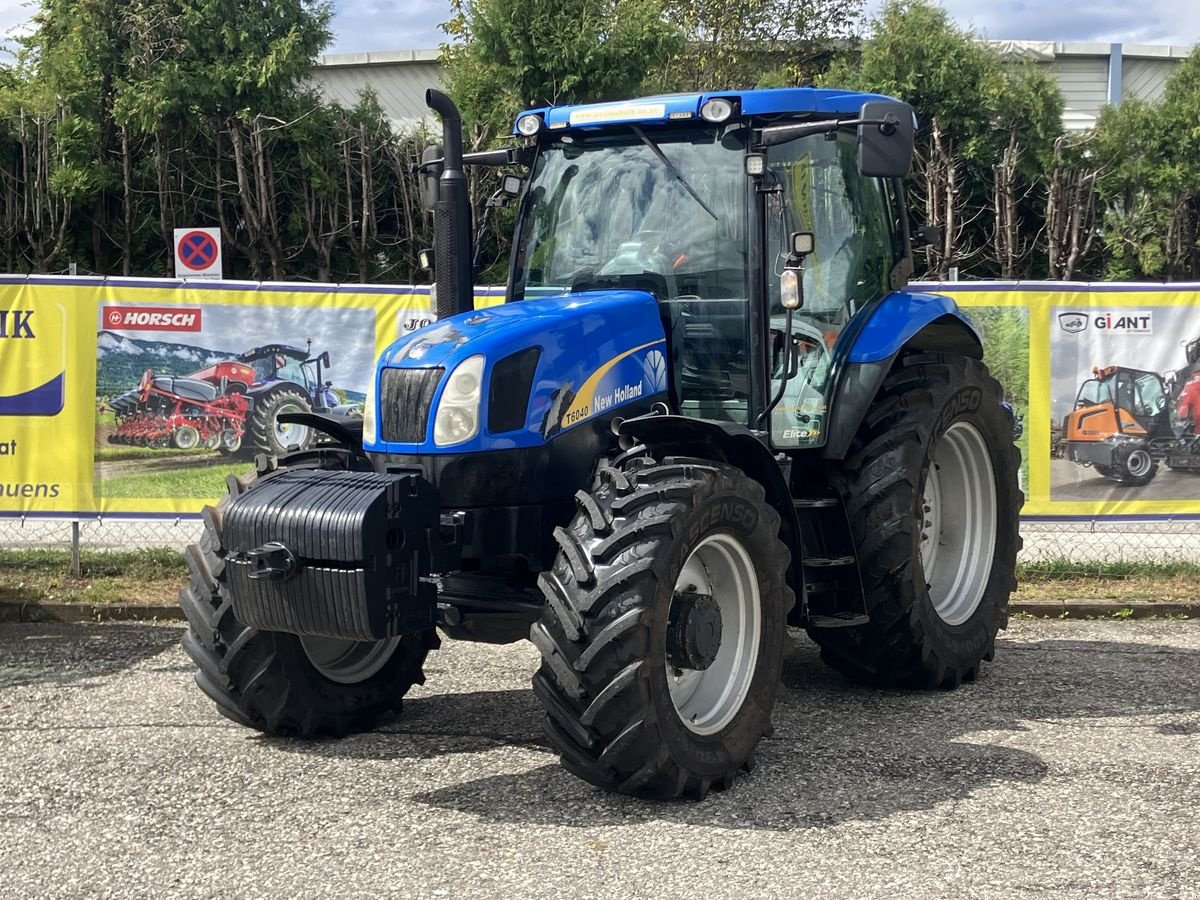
[{"left": 0, "top": 277, "right": 497, "bottom": 517}]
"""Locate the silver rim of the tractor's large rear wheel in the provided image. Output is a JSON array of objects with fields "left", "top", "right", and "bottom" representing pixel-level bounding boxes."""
[{"left": 920, "top": 422, "right": 998, "bottom": 625}]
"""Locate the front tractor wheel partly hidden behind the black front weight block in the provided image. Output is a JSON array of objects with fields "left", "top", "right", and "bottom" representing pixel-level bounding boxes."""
[{"left": 179, "top": 457, "right": 439, "bottom": 738}]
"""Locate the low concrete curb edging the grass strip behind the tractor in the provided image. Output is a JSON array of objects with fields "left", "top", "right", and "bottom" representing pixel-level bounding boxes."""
[{"left": 0, "top": 600, "right": 1200, "bottom": 622}]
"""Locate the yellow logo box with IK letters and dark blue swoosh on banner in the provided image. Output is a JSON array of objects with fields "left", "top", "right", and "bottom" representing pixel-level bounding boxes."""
[{"left": 0, "top": 304, "right": 66, "bottom": 415}]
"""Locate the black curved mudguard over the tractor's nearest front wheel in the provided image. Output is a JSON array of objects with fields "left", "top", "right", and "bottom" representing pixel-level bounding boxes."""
[{"left": 617, "top": 415, "right": 800, "bottom": 589}]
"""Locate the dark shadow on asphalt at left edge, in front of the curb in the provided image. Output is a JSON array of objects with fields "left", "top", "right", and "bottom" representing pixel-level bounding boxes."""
[{"left": 0, "top": 623, "right": 179, "bottom": 690}]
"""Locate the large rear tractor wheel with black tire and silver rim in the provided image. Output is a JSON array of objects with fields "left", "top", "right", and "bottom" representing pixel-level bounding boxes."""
[{"left": 809, "top": 354, "right": 1024, "bottom": 688}]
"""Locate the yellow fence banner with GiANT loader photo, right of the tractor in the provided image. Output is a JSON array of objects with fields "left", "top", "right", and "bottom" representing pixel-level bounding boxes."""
[{"left": 936, "top": 282, "right": 1200, "bottom": 520}]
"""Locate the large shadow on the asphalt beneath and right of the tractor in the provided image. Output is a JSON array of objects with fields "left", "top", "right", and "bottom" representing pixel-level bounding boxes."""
[{"left": 278, "top": 641, "right": 1200, "bottom": 829}]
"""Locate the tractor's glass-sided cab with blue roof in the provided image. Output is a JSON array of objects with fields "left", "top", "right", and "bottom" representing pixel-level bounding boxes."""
[{"left": 509, "top": 89, "right": 913, "bottom": 450}]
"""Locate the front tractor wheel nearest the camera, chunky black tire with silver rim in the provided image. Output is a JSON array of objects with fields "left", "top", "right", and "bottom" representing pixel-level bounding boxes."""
[{"left": 529, "top": 450, "right": 794, "bottom": 799}]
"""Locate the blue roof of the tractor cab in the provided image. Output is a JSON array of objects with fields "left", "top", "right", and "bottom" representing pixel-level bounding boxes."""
[{"left": 512, "top": 88, "right": 894, "bottom": 134}]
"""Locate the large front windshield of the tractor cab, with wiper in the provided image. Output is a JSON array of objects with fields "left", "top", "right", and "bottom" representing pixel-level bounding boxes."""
[{"left": 514, "top": 126, "right": 748, "bottom": 301}]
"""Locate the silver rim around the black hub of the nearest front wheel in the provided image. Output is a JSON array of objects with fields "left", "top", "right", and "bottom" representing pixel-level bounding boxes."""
[{"left": 666, "top": 534, "right": 762, "bottom": 734}]
